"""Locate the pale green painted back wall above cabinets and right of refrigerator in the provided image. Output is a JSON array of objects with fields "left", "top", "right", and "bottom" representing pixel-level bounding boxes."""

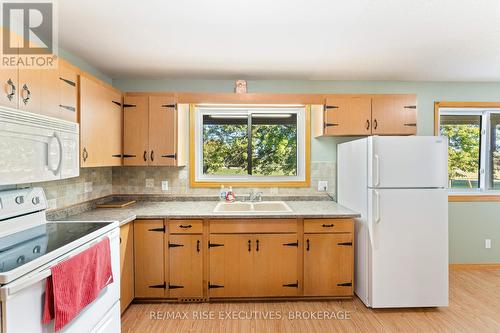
[{"left": 113, "top": 79, "right": 500, "bottom": 263}]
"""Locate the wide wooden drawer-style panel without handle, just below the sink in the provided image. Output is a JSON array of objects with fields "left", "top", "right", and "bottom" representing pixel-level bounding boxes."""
[{"left": 210, "top": 219, "right": 297, "bottom": 234}]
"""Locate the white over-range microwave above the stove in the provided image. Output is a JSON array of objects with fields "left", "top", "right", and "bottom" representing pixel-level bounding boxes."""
[{"left": 0, "top": 107, "right": 80, "bottom": 185}]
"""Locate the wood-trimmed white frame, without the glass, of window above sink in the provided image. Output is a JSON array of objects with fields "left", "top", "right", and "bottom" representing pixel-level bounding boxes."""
[{"left": 189, "top": 104, "right": 311, "bottom": 187}]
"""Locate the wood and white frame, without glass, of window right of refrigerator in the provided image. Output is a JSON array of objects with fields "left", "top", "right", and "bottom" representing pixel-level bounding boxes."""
[{"left": 434, "top": 102, "right": 500, "bottom": 201}]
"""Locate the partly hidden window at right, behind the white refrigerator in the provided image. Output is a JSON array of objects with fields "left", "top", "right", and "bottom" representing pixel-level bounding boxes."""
[{"left": 439, "top": 108, "right": 500, "bottom": 193}]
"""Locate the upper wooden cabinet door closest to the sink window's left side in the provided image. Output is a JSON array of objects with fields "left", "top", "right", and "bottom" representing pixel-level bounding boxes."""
[{"left": 149, "top": 96, "right": 177, "bottom": 166}]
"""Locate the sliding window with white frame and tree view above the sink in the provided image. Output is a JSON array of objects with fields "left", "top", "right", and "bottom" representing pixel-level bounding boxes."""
[{"left": 192, "top": 106, "right": 308, "bottom": 186}]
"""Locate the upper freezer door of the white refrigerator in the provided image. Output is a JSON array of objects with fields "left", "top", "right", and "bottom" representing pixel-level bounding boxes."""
[{"left": 368, "top": 136, "right": 448, "bottom": 188}]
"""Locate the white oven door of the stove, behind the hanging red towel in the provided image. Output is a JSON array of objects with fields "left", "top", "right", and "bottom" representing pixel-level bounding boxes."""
[{"left": 0, "top": 229, "right": 120, "bottom": 333}]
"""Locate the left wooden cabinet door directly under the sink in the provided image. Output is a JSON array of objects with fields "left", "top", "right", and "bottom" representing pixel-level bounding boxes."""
[{"left": 208, "top": 234, "right": 255, "bottom": 297}]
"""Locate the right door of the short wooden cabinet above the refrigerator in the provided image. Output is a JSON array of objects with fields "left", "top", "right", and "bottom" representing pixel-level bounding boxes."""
[{"left": 372, "top": 95, "right": 417, "bottom": 135}]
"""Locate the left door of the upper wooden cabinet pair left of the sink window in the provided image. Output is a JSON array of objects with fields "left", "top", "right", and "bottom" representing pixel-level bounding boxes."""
[{"left": 123, "top": 96, "right": 149, "bottom": 165}]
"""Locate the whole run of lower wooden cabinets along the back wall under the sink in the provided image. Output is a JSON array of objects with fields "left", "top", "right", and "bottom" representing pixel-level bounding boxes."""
[{"left": 129, "top": 219, "right": 354, "bottom": 302}]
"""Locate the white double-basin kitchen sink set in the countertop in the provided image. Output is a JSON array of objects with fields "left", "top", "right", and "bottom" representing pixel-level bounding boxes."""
[{"left": 214, "top": 201, "right": 292, "bottom": 214}]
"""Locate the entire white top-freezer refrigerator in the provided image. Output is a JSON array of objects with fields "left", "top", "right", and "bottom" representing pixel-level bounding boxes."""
[{"left": 337, "top": 136, "right": 448, "bottom": 308}]
